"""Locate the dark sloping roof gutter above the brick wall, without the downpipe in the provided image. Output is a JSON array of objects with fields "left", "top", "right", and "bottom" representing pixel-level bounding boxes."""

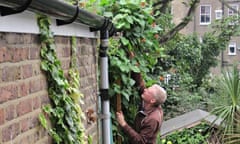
[{"left": 0, "top": 0, "right": 115, "bottom": 36}]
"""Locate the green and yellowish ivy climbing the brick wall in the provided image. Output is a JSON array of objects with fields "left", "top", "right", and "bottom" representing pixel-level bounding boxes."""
[{"left": 37, "top": 15, "right": 86, "bottom": 144}]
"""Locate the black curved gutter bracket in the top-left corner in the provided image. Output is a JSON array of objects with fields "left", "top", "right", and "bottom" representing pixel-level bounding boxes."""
[{"left": 0, "top": 0, "right": 32, "bottom": 16}]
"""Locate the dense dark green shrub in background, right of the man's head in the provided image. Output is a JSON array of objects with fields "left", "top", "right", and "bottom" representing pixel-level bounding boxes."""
[{"left": 158, "top": 24, "right": 236, "bottom": 89}]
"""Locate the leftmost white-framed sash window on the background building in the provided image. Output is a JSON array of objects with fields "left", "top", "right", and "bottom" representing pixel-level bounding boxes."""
[{"left": 200, "top": 5, "right": 211, "bottom": 25}]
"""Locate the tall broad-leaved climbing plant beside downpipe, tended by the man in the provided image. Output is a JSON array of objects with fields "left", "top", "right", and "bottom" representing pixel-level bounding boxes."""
[{"left": 103, "top": 0, "right": 163, "bottom": 142}]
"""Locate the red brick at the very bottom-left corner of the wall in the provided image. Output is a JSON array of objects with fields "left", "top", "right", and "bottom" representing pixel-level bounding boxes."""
[{"left": 2, "top": 123, "right": 20, "bottom": 142}]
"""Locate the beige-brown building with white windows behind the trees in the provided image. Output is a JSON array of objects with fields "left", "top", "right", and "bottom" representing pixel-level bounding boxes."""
[{"left": 172, "top": 0, "right": 240, "bottom": 74}]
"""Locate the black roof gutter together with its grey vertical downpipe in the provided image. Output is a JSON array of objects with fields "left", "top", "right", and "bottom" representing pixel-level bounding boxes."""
[{"left": 0, "top": 0, "right": 115, "bottom": 144}]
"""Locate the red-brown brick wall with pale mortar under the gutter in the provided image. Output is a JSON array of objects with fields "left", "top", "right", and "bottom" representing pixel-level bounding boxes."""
[{"left": 0, "top": 32, "right": 98, "bottom": 144}]
